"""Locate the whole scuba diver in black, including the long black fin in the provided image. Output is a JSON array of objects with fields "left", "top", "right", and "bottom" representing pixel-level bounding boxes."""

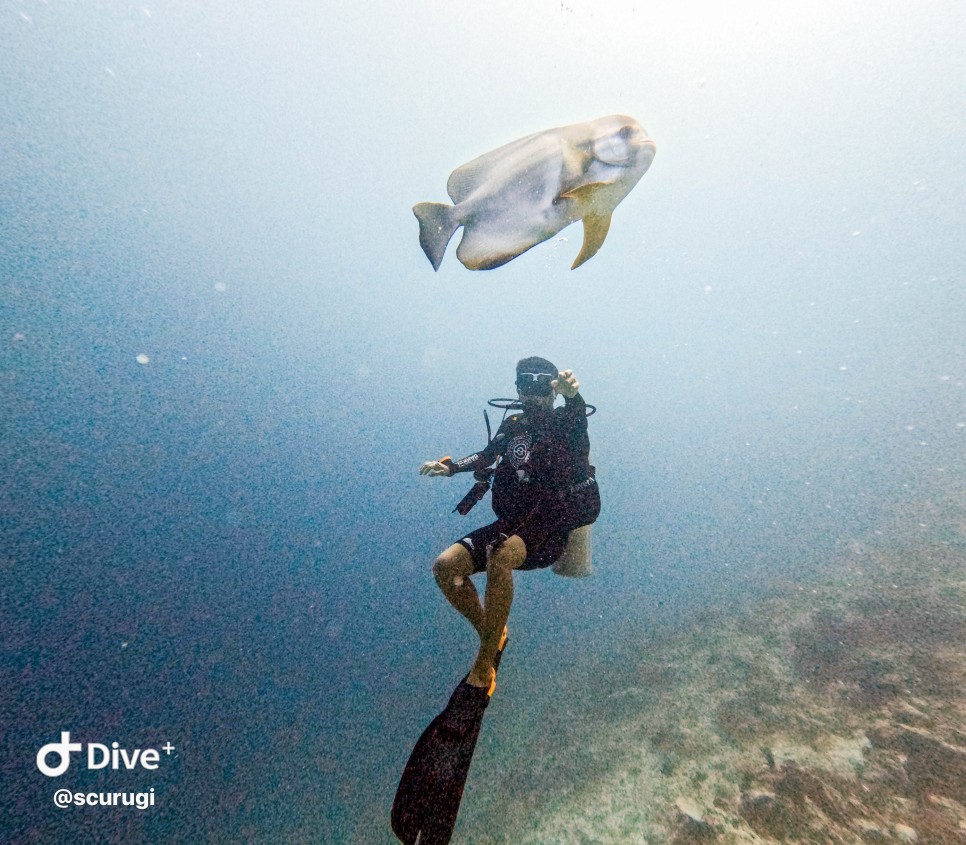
[{"left": 390, "top": 358, "right": 600, "bottom": 845}]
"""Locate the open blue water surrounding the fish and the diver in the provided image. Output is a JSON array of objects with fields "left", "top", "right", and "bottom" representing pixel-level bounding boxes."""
[{"left": 0, "top": 0, "right": 966, "bottom": 843}]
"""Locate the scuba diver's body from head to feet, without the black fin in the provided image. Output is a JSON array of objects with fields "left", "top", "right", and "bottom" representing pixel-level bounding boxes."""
[{"left": 419, "top": 357, "right": 600, "bottom": 695}]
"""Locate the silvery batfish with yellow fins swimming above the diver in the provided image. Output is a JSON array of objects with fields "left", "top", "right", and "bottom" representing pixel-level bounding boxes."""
[{"left": 413, "top": 114, "right": 656, "bottom": 270}]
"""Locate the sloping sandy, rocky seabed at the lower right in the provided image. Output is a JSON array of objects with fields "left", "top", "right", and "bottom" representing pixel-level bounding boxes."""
[{"left": 454, "top": 502, "right": 966, "bottom": 845}]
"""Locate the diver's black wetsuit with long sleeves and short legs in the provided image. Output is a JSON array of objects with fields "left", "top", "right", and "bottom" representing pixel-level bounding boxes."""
[{"left": 452, "top": 393, "right": 600, "bottom": 572}]
